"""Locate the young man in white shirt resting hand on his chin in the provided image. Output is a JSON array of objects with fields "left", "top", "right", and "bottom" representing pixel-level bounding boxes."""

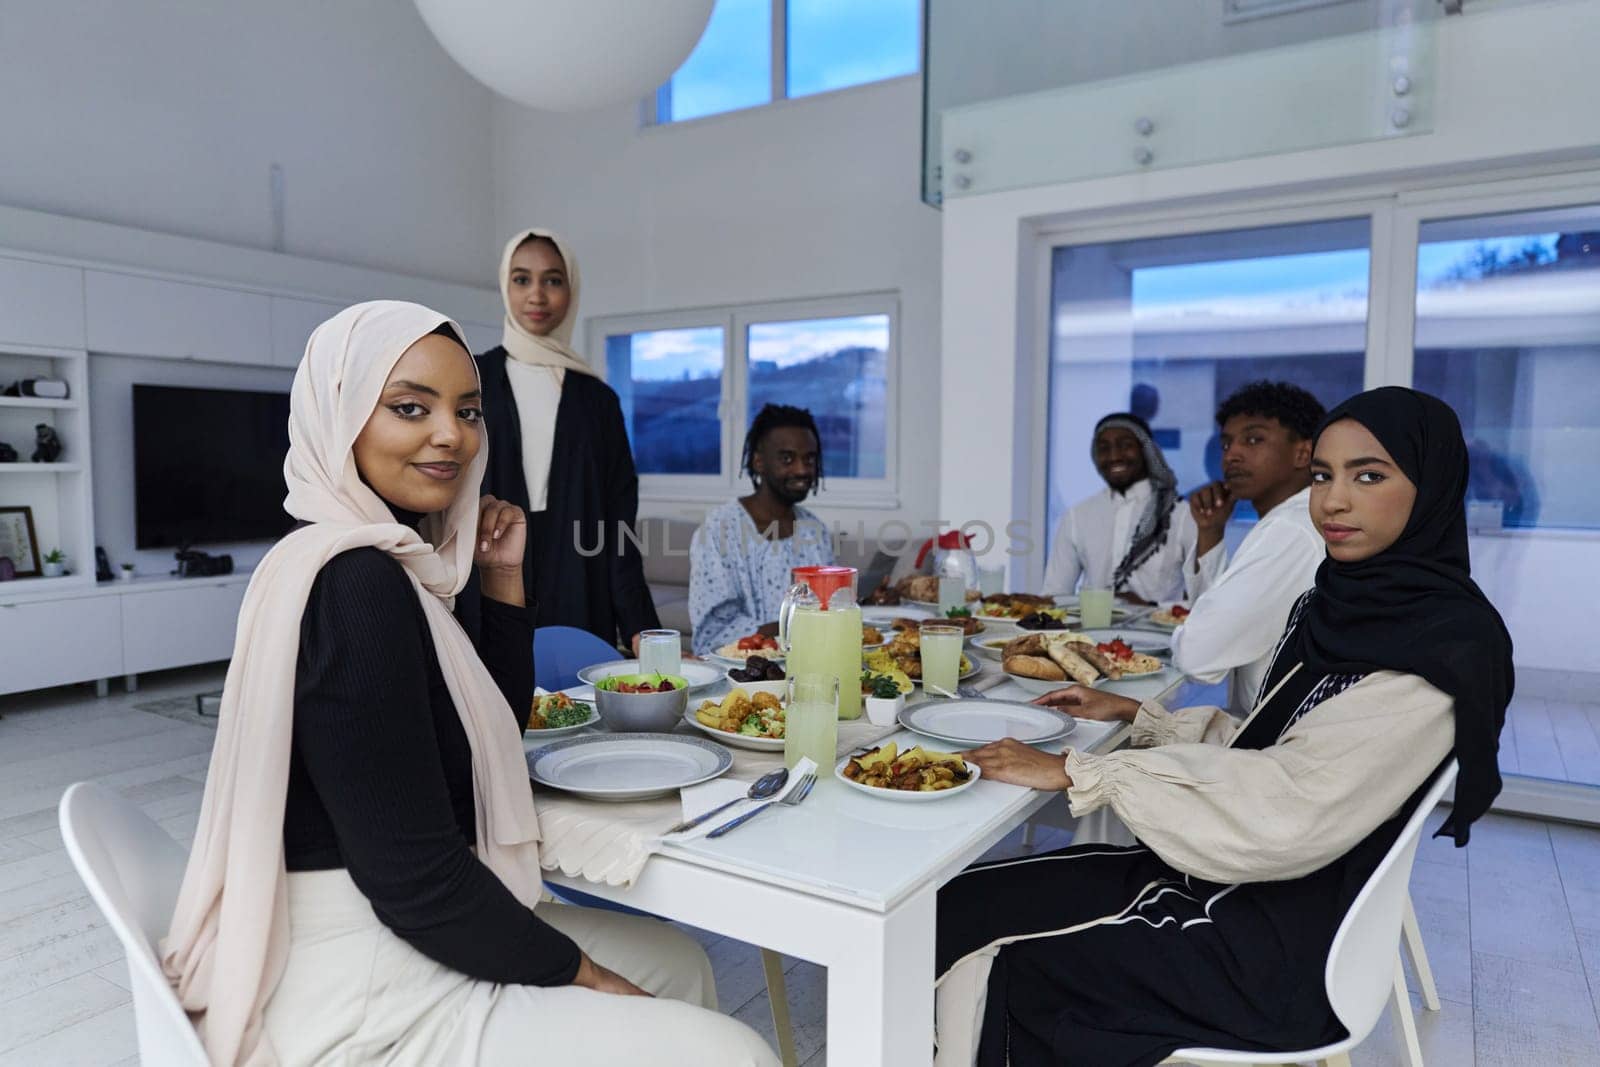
[{"left": 1173, "top": 381, "right": 1326, "bottom": 715}]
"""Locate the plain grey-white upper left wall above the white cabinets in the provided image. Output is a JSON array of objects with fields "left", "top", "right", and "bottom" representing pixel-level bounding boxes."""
[{"left": 0, "top": 0, "right": 496, "bottom": 285}]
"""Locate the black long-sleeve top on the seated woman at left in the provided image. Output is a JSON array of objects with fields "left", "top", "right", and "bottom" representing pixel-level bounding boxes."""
[{"left": 283, "top": 549, "right": 579, "bottom": 985}]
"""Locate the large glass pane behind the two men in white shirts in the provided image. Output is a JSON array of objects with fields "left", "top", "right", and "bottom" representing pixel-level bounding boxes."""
[{"left": 1046, "top": 218, "right": 1370, "bottom": 550}]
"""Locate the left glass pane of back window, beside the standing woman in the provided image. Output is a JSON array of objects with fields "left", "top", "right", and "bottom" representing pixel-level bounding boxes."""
[{"left": 605, "top": 326, "right": 726, "bottom": 475}]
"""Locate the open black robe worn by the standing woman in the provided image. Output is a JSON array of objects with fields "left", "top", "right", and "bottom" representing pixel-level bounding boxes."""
[{"left": 467, "top": 346, "right": 661, "bottom": 646}]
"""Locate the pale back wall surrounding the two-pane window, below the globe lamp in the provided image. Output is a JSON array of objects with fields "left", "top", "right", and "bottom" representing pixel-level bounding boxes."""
[{"left": 494, "top": 77, "right": 939, "bottom": 528}]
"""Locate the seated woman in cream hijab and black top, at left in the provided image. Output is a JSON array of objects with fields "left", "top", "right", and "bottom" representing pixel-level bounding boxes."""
[{"left": 162, "top": 301, "right": 776, "bottom": 1065}]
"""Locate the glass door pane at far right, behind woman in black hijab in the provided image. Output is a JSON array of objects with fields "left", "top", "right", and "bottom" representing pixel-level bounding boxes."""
[{"left": 1413, "top": 206, "right": 1600, "bottom": 530}]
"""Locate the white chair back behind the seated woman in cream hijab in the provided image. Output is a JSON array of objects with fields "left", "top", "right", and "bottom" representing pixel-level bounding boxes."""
[{"left": 61, "top": 782, "right": 206, "bottom": 1067}]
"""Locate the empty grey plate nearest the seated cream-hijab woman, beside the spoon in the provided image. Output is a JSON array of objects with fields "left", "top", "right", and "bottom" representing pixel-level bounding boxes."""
[{"left": 528, "top": 734, "right": 733, "bottom": 801}]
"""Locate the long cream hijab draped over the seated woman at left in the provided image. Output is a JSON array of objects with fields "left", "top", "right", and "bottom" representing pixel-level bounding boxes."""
[{"left": 162, "top": 301, "right": 541, "bottom": 1064}]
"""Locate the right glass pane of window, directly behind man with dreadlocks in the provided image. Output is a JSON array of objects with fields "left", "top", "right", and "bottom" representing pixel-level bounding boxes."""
[{"left": 746, "top": 315, "right": 890, "bottom": 478}]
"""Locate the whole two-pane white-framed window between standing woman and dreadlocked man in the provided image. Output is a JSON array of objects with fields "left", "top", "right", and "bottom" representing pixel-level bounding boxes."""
[{"left": 601, "top": 294, "right": 898, "bottom": 504}]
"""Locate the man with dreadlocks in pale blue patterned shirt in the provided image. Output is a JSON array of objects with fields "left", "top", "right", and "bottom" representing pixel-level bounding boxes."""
[{"left": 690, "top": 403, "right": 834, "bottom": 656}]
